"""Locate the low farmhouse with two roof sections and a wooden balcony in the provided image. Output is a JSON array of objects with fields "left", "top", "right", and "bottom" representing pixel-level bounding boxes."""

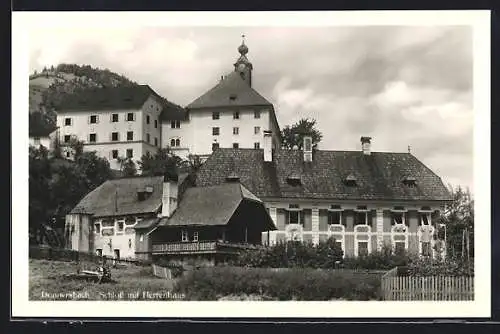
[{"left": 65, "top": 174, "right": 275, "bottom": 263}]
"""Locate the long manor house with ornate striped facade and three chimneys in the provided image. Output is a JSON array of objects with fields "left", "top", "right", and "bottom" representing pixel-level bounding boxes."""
[{"left": 196, "top": 133, "right": 451, "bottom": 256}]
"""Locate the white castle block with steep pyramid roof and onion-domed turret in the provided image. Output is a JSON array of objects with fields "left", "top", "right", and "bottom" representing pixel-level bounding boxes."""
[{"left": 179, "top": 38, "right": 281, "bottom": 156}]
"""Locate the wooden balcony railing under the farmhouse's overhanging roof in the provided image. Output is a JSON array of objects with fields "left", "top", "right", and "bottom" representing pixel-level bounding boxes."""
[{"left": 152, "top": 240, "right": 259, "bottom": 254}]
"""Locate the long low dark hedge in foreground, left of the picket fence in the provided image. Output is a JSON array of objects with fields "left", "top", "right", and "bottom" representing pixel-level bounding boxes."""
[{"left": 174, "top": 266, "right": 380, "bottom": 301}]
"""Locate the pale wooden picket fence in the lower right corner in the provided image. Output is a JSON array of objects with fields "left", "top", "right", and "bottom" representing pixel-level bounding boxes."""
[{"left": 381, "top": 268, "right": 474, "bottom": 300}]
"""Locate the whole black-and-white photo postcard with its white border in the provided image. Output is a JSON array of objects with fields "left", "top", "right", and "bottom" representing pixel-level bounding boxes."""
[{"left": 12, "top": 11, "right": 491, "bottom": 317}]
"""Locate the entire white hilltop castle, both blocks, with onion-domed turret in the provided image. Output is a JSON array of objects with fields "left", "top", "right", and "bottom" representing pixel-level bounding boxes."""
[{"left": 56, "top": 42, "right": 281, "bottom": 169}]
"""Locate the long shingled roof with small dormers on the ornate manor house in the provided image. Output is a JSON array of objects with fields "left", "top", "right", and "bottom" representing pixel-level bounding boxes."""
[{"left": 196, "top": 148, "right": 450, "bottom": 201}]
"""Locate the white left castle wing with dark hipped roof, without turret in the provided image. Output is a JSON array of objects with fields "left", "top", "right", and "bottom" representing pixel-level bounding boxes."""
[{"left": 56, "top": 85, "right": 184, "bottom": 169}]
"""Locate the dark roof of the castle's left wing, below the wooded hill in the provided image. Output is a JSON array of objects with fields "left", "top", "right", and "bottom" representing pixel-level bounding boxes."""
[{"left": 55, "top": 85, "right": 187, "bottom": 120}]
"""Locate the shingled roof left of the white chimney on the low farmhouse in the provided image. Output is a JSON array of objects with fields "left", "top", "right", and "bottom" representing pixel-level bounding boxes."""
[{"left": 71, "top": 176, "right": 163, "bottom": 217}]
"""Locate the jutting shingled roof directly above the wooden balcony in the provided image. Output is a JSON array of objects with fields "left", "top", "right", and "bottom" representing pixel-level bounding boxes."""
[{"left": 159, "top": 183, "right": 270, "bottom": 226}]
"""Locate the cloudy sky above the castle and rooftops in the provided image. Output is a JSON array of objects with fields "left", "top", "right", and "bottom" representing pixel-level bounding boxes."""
[{"left": 30, "top": 26, "right": 474, "bottom": 190}]
